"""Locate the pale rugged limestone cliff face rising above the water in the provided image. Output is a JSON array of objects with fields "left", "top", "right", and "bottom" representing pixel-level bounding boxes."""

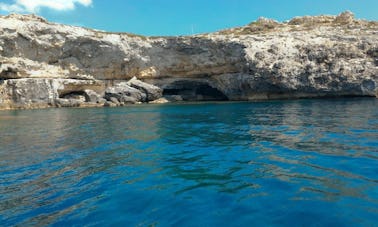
[{"left": 0, "top": 12, "right": 378, "bottom": 108}]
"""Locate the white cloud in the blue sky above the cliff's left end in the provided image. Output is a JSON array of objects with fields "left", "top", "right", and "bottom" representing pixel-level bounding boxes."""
[{"left": 0, "top": 0, "right": 92, "bottom": 13}]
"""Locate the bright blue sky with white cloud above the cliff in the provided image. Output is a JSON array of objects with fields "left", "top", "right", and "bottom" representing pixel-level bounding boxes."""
[{"left": 0, "top": 0, "right": 378, "bottom": 36}]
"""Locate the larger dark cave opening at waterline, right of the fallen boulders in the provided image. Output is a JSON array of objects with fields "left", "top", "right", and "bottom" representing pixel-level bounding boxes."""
[{"left": 163, "top": 80, "right": 228, "bottom": 101}]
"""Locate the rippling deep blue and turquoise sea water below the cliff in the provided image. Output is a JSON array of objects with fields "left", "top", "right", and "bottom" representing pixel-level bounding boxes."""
[{"left": 0, "top": 99, "right": 378, "bottom": 226}]
